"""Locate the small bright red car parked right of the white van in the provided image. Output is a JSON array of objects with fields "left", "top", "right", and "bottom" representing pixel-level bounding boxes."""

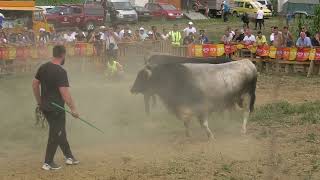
[{"left": 145, "top": 3, "right": 183, "bottom": 19}]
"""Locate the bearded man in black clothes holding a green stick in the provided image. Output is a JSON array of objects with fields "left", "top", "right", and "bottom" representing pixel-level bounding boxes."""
[{"left": 32, "top": 45, "right": 79, "bottom": 170}]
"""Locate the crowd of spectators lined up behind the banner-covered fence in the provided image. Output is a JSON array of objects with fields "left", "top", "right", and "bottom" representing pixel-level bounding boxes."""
[{"left": 0, "top": 22, "right": 320, "bottom": 49}]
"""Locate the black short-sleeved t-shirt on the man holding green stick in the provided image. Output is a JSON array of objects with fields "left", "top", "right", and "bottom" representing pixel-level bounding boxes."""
[{"left": 35, "top": 62, "right": 69, "bottom": 111}]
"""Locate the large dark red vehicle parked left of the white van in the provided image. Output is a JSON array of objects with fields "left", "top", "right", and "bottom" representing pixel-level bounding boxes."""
[{"left": 46, "top": 4, "right": 105, "bottom": 30}]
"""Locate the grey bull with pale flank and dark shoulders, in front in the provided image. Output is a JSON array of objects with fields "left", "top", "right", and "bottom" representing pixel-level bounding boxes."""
[{"left": 131, "top": 60, "right": 257, "bottom": 139}]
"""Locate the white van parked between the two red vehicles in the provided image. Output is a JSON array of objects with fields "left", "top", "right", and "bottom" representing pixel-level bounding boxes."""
[{"left": 106, "top": 0, "right": 138, "bottom": 23}]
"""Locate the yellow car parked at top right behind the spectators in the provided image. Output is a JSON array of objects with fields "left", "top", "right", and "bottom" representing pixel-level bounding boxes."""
[{"left": 232, "top": 0, "right": 272, "bottom": 18}]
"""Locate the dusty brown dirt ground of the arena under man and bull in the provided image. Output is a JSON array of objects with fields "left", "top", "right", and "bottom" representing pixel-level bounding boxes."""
[{"left": 0, "top": 59, "right": 320, "bottom": 180}]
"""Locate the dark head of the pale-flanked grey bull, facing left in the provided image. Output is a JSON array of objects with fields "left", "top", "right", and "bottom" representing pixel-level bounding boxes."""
[{"left": 130, "top": 66, "right": 152, "bottom": 94}]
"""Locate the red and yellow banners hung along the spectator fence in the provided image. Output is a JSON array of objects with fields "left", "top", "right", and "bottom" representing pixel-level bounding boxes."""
[{"left": 0, "top": 43, "right": 320, "bottom": 61}]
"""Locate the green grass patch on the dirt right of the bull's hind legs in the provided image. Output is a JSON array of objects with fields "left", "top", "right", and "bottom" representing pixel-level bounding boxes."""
[{"left": 251, "top": 101, "right": 320, "bottom": 124}]
